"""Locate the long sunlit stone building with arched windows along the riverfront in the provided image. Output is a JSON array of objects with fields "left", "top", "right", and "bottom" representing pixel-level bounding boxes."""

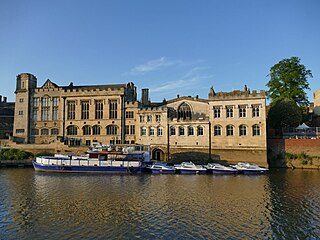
[{"left": 14, "top": 73, "right": 267, "bottom": 165}]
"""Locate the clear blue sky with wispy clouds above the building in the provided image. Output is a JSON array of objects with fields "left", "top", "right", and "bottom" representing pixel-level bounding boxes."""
[{"left": 0, "top": 0, "right": 320, "bottom": 101}]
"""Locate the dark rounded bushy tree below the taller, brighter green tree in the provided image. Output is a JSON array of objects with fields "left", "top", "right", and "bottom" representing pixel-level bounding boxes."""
[{"left": 268, "top": 100, "right": 302, "bottom": 129}]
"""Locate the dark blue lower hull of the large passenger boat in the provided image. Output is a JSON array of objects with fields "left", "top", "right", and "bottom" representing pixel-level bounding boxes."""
[{"left": 32, "top": 161, "right": 145, "bottom": 173}]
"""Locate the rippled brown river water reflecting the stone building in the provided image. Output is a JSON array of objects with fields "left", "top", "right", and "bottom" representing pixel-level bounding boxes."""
[{"left": 0, "top": 168, "right": 320, "bottom": 240}]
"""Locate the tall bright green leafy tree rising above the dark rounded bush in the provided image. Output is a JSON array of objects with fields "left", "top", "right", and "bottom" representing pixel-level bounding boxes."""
[{"left": 266, "top": 57, "right": 312, "bottom": 107}]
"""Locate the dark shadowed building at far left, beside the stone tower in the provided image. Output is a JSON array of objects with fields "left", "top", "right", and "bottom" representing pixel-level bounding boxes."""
[{"left": 0, "top": 95, "right": 14, "bottom": 139}]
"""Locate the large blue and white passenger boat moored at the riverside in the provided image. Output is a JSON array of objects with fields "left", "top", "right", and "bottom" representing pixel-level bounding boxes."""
[{"left": 32, "top": 144, "right": 152, "bottom": 173}]
